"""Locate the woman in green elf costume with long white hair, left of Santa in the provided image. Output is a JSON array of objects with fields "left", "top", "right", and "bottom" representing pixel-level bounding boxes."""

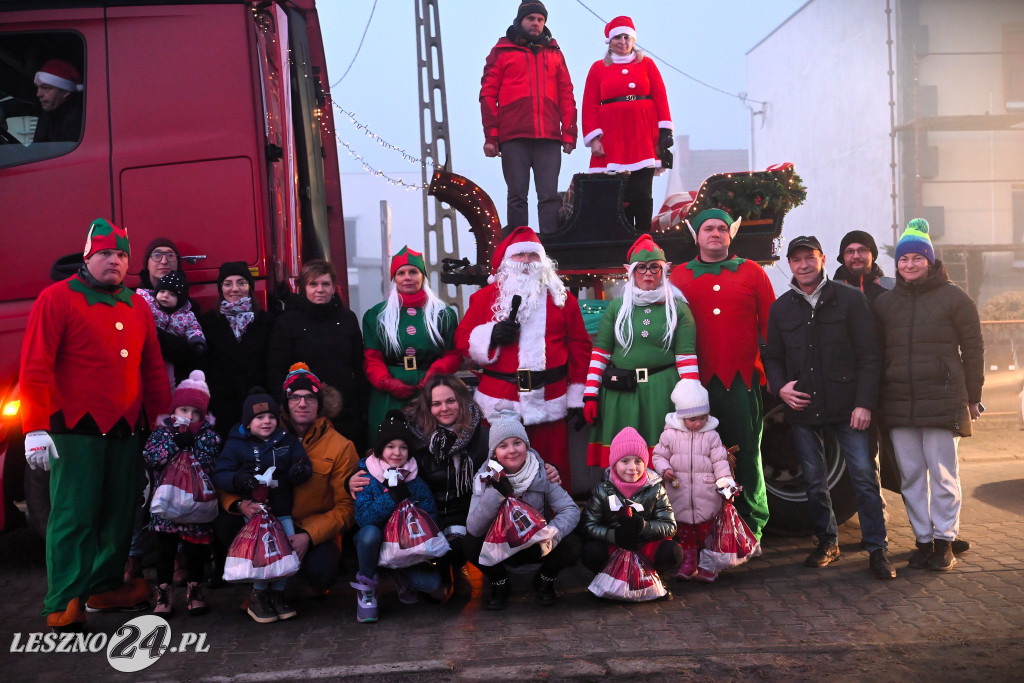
[{"left": 362, "top": 247, "right": 462, "bottom": 437}]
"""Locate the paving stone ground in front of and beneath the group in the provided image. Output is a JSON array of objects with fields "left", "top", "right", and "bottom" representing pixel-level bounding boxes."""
[{"left": 0, "top": 425, "right": 1024, "bottom": 683}]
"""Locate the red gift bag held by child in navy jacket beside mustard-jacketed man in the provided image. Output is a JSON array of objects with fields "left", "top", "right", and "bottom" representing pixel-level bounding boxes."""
[{"left": 224, "top": 509, "right": 300, "bottom": 582}]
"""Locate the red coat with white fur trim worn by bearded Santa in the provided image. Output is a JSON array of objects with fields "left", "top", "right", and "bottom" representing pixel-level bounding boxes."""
[{"left": 455, "top": 285, "right": 591, "bottom": 425}]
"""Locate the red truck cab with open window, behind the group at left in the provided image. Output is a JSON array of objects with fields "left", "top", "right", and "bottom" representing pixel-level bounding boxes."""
[{"left": 0, "top": 0, "right": 347, "bottom": 528}]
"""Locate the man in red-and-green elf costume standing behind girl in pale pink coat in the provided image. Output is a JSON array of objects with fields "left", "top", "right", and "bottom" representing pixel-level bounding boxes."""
[{"left": 671, "top": 209, "right": 775, "bottom": 539}]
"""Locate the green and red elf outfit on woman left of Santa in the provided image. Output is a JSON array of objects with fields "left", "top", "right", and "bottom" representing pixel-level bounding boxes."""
[{"left": 362, "top": 290, "right": 462, "bottom": 442}]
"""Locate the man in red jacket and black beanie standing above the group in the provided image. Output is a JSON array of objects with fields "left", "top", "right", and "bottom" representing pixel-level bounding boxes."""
[{"left": 480, "top": 1, "right": 577, "bottom": 232}]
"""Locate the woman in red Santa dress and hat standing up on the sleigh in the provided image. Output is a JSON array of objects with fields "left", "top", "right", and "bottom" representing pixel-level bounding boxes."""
[{"left": 583, "top": 16, "right": 673, "bottom": 232}]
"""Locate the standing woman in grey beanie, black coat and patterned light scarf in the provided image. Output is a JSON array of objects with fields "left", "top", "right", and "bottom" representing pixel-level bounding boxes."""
[{"left": 199, "top": 261, "right": 273, "bottom": 438}]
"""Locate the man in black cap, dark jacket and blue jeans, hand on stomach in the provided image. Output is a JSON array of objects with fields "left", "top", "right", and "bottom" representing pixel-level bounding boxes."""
[{"left": 764, "top": 237, "right": 896, "bottom": 579}]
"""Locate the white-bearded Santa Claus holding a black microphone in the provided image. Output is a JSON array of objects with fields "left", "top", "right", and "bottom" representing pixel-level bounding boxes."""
[{"left": 455, "top": 227, "right": 591, "bottom": 490}]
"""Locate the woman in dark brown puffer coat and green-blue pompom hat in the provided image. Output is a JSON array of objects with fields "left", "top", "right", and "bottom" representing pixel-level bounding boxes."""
[{"left": 872, "top": 218, "right": 985, "bottom": 570}]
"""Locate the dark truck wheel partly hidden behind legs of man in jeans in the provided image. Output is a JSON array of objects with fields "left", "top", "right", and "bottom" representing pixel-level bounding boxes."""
[{"left": 761, "top": 403, "right": 857, "bottom": 536}]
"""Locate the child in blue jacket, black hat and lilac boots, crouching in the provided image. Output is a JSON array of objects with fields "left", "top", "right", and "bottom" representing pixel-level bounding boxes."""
[{"left": 351, "top": 411, "right": 444, "bottom": 623}]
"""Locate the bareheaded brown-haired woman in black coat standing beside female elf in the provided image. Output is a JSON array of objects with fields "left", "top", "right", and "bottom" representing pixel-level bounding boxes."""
[{"left": 266, "top": 259, "right": 370, "bottom": 453}]
